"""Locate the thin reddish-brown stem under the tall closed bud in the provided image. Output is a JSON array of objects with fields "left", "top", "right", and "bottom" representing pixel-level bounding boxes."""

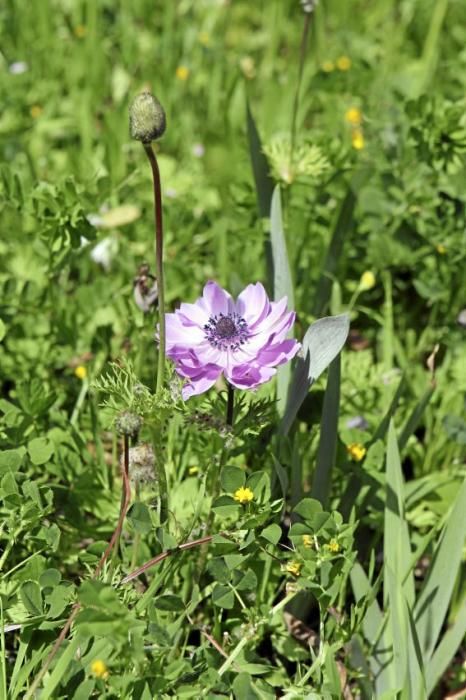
[{"left": 142, "top": 143, "right": 165, "bottom": 396}]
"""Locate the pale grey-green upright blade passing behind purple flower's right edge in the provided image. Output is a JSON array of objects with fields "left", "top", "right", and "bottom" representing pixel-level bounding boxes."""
[{"left": 270, "top": 185, "right": 294, "bottom": 416}]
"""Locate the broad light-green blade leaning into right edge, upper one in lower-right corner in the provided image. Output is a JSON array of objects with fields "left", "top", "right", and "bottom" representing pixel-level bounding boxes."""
[{"left": 414, "top": 481, "right": 466, "bottom": 667}]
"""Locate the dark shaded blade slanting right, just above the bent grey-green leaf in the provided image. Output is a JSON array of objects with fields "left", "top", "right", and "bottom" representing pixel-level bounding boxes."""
[{"left": 313, "top": 188, "right": 356, "bottom": 316}]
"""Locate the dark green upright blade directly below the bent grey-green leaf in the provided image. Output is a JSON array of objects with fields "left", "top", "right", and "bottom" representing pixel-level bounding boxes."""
[{"left": 311, "top": 355, "right": 340, "bottom": 507}]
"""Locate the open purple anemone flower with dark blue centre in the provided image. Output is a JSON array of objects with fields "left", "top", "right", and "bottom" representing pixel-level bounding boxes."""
[{"left": 166, "top": 282, "right": 300, "bottom": 399}]
